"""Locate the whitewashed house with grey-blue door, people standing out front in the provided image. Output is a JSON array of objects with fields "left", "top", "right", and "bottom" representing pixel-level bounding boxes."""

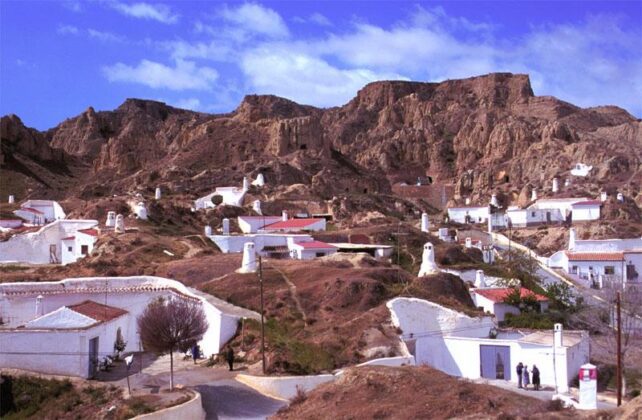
[{"left": 387, "top": 298, "right": 589, "bottom": 392}]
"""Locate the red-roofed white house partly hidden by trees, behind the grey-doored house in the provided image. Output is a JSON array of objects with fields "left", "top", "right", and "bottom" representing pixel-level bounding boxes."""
[{"left": 470, "top": 287, "right": 548, "bottom": 322}]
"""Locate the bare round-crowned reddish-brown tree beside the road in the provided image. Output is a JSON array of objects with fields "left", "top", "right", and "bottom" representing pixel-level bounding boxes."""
[{"left": 138, "top": 298, "right": 208, "bottom": 390}]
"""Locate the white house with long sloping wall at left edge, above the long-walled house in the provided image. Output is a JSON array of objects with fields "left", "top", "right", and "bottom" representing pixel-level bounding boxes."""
[{"left": 0, "top": 219, "right": 98, "bottom": 265}]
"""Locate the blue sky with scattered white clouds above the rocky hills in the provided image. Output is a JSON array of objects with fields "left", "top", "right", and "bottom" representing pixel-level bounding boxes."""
[{"left": 0, "top": 0, "right": 642, "bottom": 129}]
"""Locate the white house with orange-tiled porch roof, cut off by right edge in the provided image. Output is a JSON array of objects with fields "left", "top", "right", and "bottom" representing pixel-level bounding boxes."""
[{"left": 548, "top": 229, "right": 642, "bottom": 287}]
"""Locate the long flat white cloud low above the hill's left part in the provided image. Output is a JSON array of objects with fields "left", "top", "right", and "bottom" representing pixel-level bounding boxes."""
[{"left": 102, "top": 60, "right": 218, "bottom": 91}]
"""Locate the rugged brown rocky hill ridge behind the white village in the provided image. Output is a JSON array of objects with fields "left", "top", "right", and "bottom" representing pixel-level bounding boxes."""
[{"left": 0, "top": 73, "right": 642, "bottom": 210}]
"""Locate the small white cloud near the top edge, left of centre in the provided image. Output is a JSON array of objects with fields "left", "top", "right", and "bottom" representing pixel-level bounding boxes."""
[{"left": 220, "top": 3, "right": 290, "bottom": 38}]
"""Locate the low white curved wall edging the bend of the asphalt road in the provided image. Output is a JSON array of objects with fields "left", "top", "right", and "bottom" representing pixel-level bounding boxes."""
[{"left": 236, "top": 374, "right": 336, "bottom": 400}]
